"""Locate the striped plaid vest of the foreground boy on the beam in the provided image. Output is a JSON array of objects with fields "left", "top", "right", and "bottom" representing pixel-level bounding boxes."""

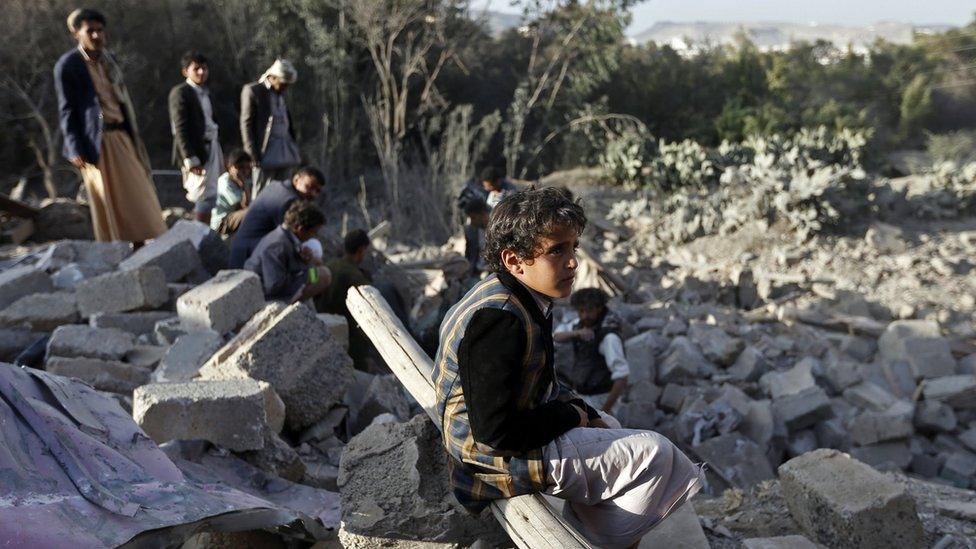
[{"left": 433, "top": 274, "right": 560, "bottom": 512}]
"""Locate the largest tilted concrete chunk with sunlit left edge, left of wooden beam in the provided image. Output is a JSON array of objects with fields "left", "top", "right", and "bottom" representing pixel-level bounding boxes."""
[{"left": 200, "top": 302, "right": 352, "bottom": 430}]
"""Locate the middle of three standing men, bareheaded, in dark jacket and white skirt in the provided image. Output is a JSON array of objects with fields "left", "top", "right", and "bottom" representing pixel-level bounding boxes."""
[{"left": 169, "top": 51, "right": 224, "bottom": 224}]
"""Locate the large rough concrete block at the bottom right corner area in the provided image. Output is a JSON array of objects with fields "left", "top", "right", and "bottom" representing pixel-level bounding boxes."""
[{"left": 779, "top": 449, "right": 925, "bottom": 549}]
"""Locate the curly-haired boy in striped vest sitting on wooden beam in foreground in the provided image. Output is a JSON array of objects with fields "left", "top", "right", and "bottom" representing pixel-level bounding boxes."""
[{"left": 433, "top": 188, "right": 701, "bottom": 548}]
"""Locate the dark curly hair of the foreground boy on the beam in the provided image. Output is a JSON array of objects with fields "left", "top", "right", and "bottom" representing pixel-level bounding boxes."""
[{"left": 482, "top": 187, "right": 586, "bottom": 273}]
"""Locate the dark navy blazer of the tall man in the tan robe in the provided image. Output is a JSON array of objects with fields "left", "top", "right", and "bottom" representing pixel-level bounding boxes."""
[{"left": 54, "top": 48, "right": 133, "bottom": 164}]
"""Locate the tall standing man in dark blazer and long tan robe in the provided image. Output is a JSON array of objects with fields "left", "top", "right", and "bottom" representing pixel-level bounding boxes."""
[{"left": 54, "top": 9, "right": 166, "bottom": 244}]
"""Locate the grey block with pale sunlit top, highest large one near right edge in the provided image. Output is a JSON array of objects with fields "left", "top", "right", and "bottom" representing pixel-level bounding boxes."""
[{"left": 878, "top": 320, "right": 956, "bottom": 379}]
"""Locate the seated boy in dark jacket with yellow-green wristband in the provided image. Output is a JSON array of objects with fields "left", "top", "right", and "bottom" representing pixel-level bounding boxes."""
[{"left": 244, "top": 200, "right": 332, "bottom": 303}]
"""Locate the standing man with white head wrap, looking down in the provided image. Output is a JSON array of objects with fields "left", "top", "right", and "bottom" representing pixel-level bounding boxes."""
[{"left": 241, "top": 59, "right": 301, "bottom": 197}]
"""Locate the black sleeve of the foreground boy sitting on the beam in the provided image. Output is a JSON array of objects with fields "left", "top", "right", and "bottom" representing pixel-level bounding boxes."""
[{"left": 458, "top": 309, "right": 580, "bottom": 452}]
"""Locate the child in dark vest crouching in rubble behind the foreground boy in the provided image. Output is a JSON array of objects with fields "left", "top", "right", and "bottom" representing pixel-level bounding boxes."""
[{"left": 553, "top": 288, "right": 630, "bottom": 413}]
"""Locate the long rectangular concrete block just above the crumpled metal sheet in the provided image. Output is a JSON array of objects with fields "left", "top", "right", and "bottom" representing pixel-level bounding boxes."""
[{"left": 132, "top": 379, "right": 285, "bottom": 451}]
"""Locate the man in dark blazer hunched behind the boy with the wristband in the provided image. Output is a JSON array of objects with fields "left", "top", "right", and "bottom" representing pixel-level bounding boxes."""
[{"left": 230, "top": 166, "right": 325, "bottom": 269}]
